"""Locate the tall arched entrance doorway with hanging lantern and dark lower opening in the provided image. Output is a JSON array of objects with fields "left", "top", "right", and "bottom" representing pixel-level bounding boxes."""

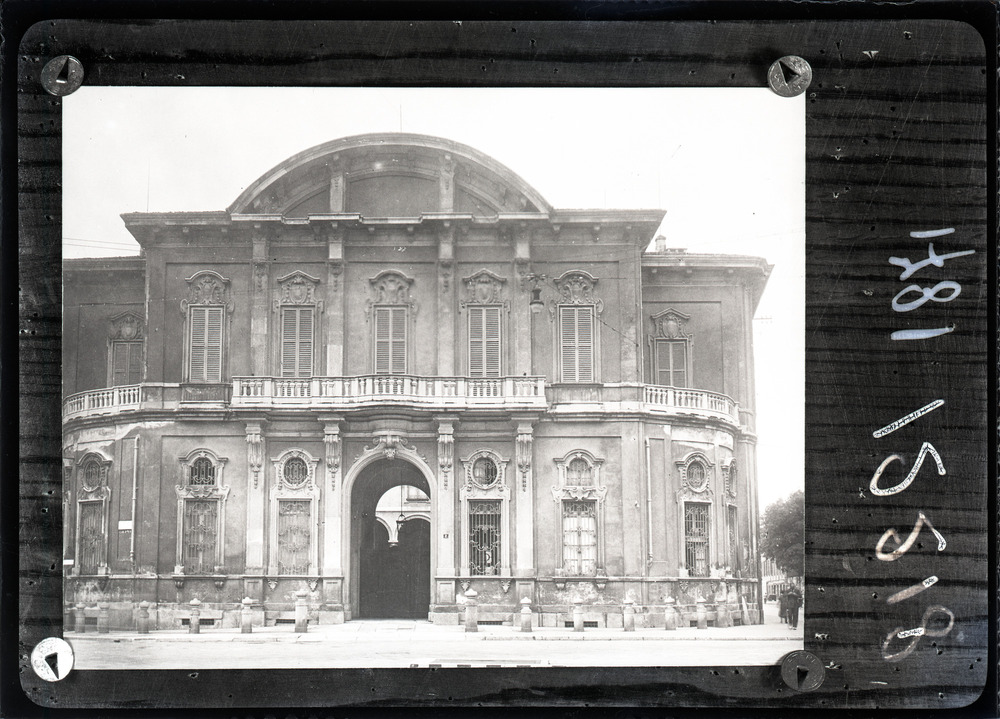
[{"left": 350, "top": 459, "right": 431, "bottom": 619}]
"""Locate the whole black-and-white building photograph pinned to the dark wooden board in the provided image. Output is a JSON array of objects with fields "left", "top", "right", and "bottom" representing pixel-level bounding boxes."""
[{"left": 63, "top": 87, "right": 805, "bottom": 669}]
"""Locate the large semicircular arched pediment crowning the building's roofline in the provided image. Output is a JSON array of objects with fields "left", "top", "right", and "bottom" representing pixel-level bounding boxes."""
[{"left": 228, "top": 133, "right": 552, "bottom": 218}]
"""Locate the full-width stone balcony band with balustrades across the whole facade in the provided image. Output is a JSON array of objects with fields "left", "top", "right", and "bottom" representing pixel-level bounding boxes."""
[{"left": 63, "top": 375, "right": 739, "bottom": 426}]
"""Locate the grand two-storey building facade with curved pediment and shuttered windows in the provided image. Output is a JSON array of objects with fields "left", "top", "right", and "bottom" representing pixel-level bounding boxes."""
[{"left": 63, "top": 134, "right": 770, "bottom": 628}]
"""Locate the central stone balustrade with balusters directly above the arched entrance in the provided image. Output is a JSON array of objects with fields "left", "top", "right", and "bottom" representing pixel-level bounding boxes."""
[{"left": 232, "top": 375, "right": 547, "bottom": 409}]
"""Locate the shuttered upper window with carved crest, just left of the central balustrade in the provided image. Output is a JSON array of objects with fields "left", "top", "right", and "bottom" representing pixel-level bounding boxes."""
[{"left": 181, "top": 270, "right": 233, "bottom": 382}]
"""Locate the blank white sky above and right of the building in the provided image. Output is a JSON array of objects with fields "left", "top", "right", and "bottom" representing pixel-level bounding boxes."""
[{"left": 63, "top": 87, "right": 805, "bottom": 511}]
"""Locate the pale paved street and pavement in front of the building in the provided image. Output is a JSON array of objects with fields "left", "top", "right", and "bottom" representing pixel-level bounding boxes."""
[{"left": 66, "top": 605, "right": 802, "bottom": 669}]
